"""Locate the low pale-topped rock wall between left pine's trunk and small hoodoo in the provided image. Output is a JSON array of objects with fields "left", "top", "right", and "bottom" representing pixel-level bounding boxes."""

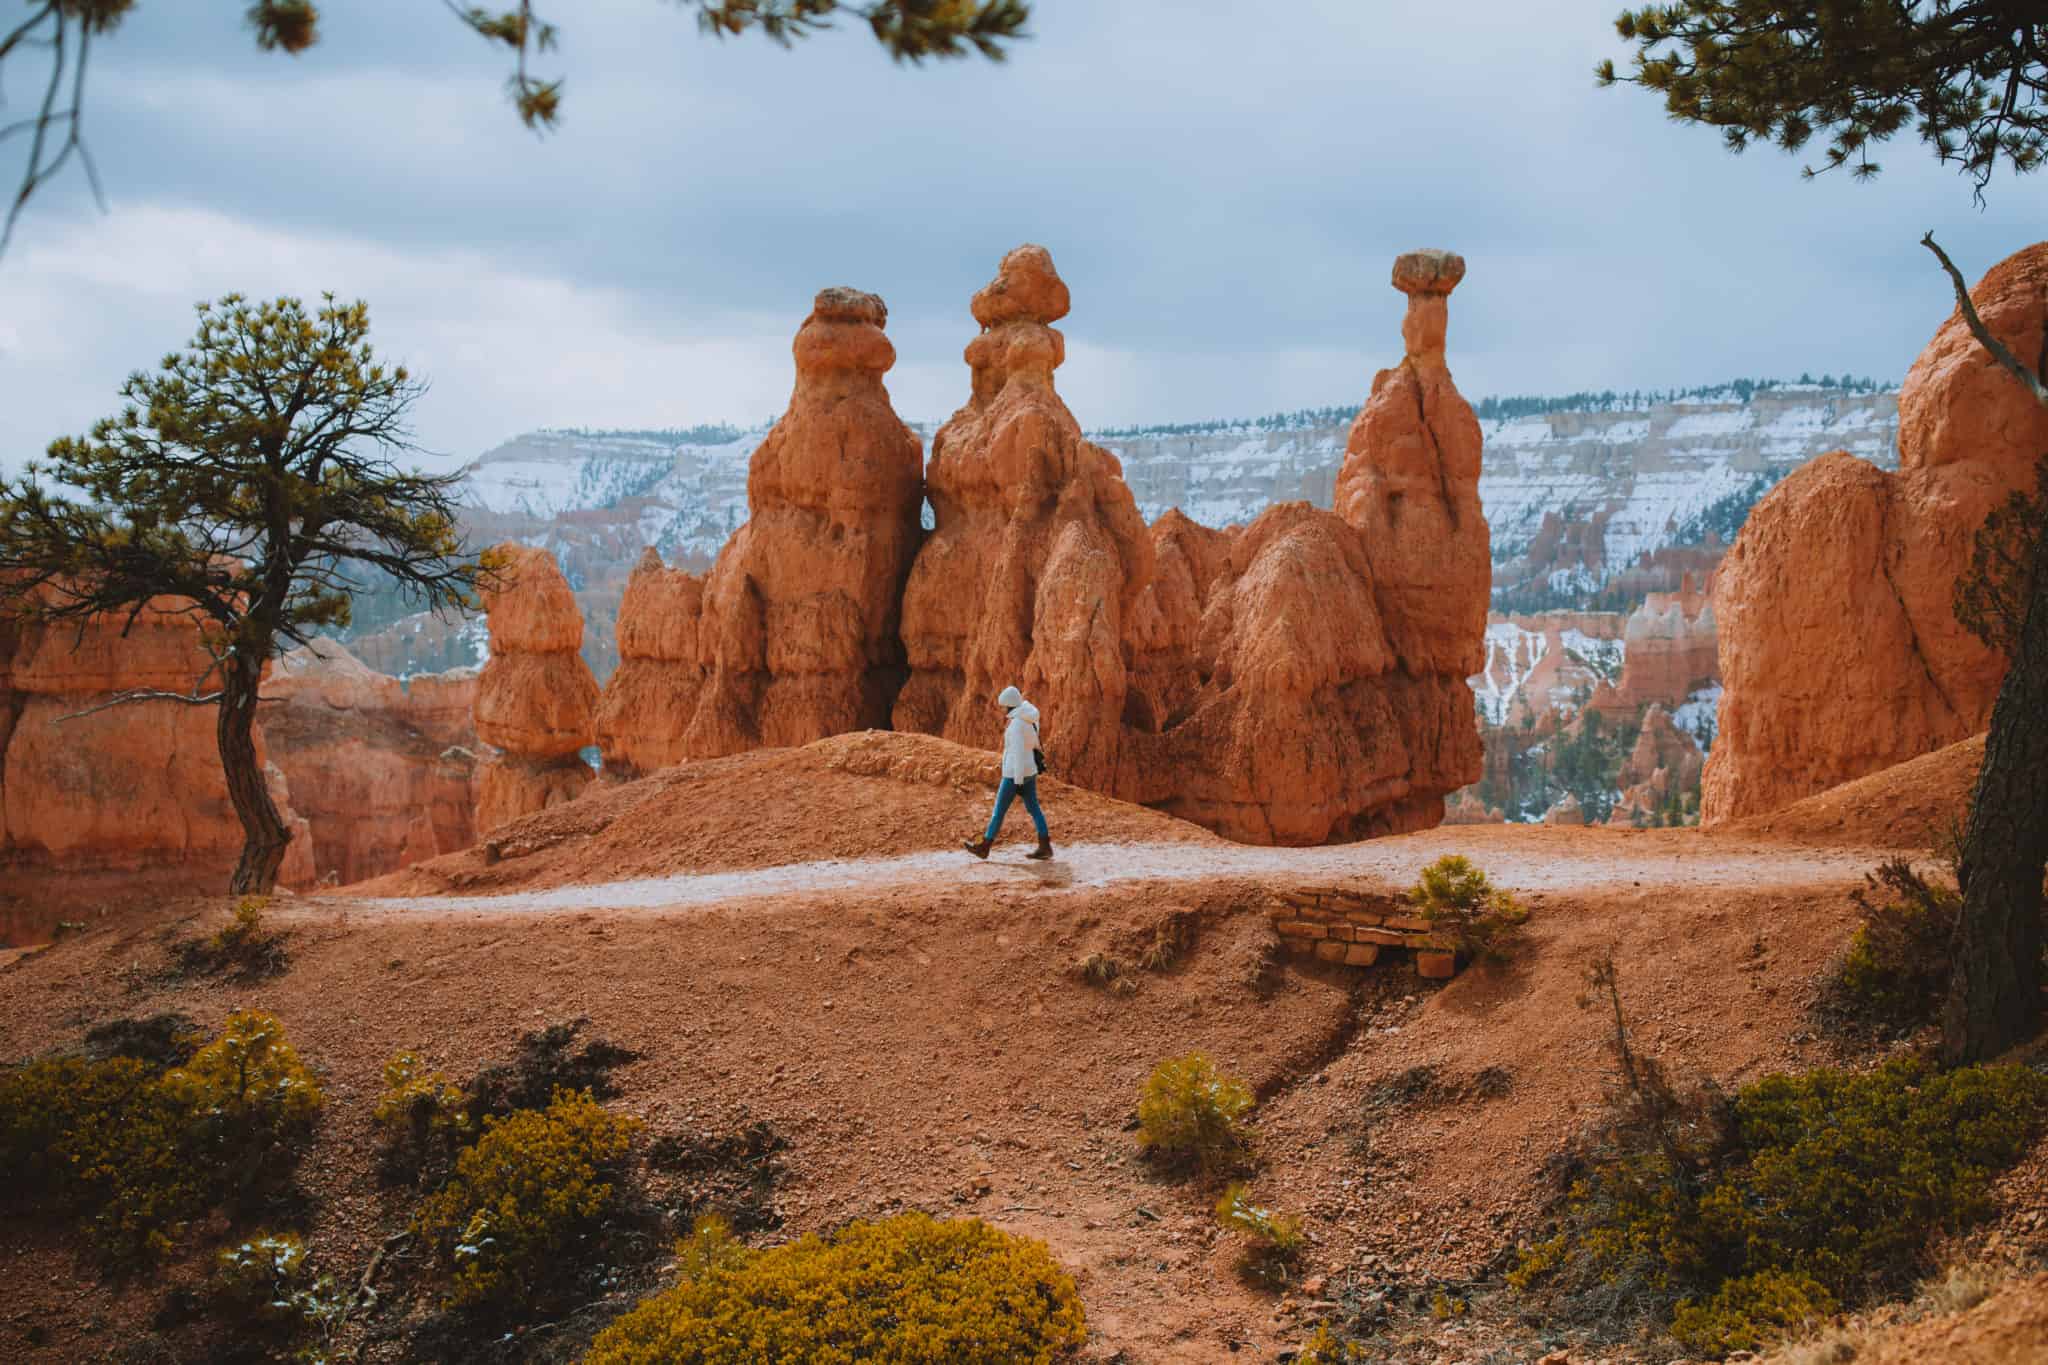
[{"left": 260, "top": 641, "right": 477, "bottom": 884}]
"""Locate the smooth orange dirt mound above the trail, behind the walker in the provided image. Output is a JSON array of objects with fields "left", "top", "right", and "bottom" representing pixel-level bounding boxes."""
[{"left": 358, "top": 731, "right": 1219, "bottom": 896}]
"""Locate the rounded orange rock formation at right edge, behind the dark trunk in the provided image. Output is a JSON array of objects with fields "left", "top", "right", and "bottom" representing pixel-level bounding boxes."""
[{"left": 1702, "top": 244, "right": 2048, "bottom": 823}]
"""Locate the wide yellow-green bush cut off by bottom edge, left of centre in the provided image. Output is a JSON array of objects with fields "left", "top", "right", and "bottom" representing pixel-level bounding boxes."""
[{"left": 584, "top": 1214, "right": 1087, "bottom": 1365}]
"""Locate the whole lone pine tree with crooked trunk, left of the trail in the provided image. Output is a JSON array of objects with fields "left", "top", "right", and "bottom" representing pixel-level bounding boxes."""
[{"left": 0, "top": 295, "right": 487, "bottom": 892}]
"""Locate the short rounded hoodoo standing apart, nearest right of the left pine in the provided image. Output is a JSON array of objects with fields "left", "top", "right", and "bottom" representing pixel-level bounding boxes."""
[{"left": 473, "top": 544, "right": 598, "bottom": 833}]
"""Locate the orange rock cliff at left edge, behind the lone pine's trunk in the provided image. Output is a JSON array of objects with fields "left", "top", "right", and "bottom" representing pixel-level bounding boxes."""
[{"left": 0, "top": 598, "right": 313, "bottom": 886}]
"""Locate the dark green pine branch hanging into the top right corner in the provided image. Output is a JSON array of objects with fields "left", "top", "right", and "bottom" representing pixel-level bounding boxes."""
[{"left": 1597, "top": 0, "right": 2048, "bottom": 194}]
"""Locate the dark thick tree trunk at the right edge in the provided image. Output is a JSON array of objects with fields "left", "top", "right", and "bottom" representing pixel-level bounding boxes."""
[{"left": 1942, "top": 534, "right": 2048, "bottom": 1064}]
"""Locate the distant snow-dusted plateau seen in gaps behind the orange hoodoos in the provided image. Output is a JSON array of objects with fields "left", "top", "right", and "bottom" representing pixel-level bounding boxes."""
[{"left": 348, "top": 383, "right": 1898, "bottom": 677}]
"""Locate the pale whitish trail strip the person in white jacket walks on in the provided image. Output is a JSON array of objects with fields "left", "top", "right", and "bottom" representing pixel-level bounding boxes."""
[{"left": 339, "top": 837, "right": 1872, "bottom": 913}]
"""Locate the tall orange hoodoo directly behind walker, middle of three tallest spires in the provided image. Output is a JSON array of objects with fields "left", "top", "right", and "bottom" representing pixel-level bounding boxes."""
[{"left": 895, "top": 246, "right": 1153, "bottom": 790}]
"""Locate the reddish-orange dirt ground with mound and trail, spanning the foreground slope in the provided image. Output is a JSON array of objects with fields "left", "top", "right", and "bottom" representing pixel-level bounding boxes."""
[{"left": 0, "top": 735, "right": 2048, "bottom": 1365}]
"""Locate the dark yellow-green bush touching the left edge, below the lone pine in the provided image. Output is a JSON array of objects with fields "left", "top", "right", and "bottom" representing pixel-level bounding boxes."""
[{"left": 0, "top": 1013, "right": 322, "bottom": 1261}]
